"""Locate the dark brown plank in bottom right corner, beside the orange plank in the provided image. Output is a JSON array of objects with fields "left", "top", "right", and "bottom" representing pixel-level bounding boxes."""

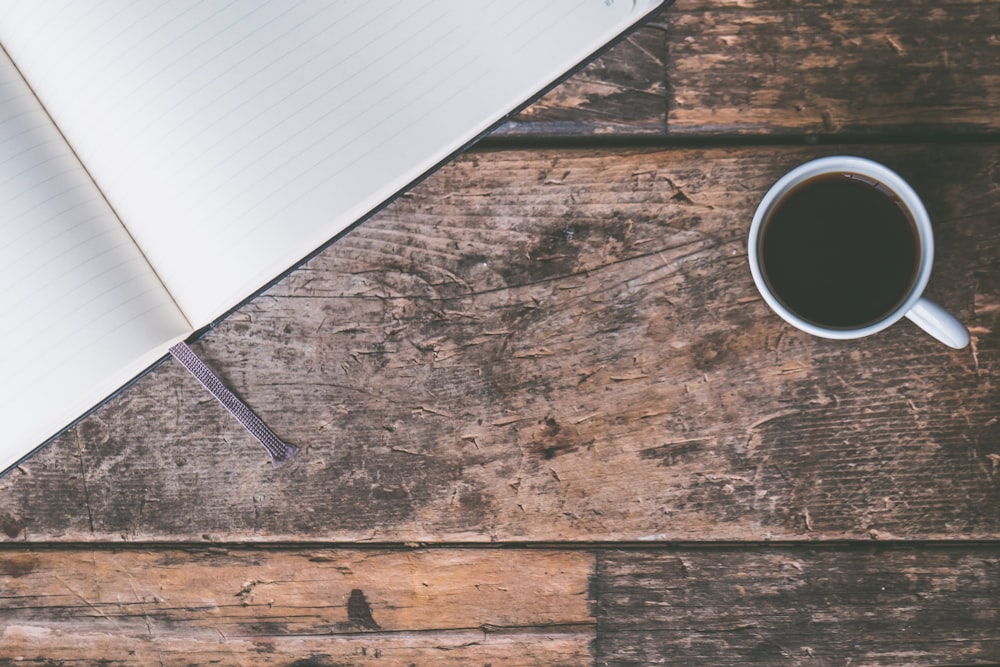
[{"left": 596, "top": 548, "right": 1000, "bottom": 667}]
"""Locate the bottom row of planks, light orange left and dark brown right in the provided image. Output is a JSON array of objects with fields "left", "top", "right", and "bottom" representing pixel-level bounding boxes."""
[{"left": 0, "top": 545, "right": 1000, "bottom": 667}]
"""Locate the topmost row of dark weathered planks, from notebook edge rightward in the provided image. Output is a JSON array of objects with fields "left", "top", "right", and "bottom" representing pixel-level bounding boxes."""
[{"left": 496, "top": 0, "right": 1000, "bottom": 138}]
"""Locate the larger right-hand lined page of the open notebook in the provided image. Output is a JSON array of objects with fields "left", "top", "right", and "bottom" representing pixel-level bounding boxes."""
[{"left": 0, "top": 0, "right": 660, "bottom": 325}]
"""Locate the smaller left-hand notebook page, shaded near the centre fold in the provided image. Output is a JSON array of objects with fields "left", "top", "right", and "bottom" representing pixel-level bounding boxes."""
[{"left": 0, "top": 51, "right": 188, "bottom": 470}]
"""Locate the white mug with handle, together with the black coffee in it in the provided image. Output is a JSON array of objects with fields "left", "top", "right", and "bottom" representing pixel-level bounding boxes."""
[{"left": 748, "top": 156, "right": 969, "bottom": 348}]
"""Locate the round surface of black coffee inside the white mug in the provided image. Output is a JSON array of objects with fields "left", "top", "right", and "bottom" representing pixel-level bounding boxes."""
[{"left": 760, "top": 174, "right": 919, "bottom": 328}]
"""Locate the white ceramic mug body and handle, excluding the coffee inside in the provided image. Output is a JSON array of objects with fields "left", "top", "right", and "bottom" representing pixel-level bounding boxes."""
[{"left": 748, "top": 155, "right": 969, "bottom": 348}]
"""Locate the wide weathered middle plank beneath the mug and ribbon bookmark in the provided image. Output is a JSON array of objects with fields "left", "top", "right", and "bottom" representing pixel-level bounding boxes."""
[{"left": 0, "top": 144, "right": 1000, "bottom": 542}]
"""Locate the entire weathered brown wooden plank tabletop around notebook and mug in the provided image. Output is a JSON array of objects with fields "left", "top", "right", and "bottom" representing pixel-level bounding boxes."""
[{"left": 0, "top": 0, "right": 1000, "bottom": 666}]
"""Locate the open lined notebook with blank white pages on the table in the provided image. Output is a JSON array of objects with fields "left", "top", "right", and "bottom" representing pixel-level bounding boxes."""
[{"left": 0, "top": 0, "right": 664, "bottom": 471}]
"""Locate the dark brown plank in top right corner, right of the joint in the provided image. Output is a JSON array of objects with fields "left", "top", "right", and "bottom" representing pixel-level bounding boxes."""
[{"left": 666, "top": 0, "right": 1000, "bottom": 135}]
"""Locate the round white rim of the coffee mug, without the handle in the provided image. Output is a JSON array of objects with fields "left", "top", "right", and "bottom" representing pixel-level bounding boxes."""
[{"left": 747, "top": 155, "right": 934, "bottom": 340}]
